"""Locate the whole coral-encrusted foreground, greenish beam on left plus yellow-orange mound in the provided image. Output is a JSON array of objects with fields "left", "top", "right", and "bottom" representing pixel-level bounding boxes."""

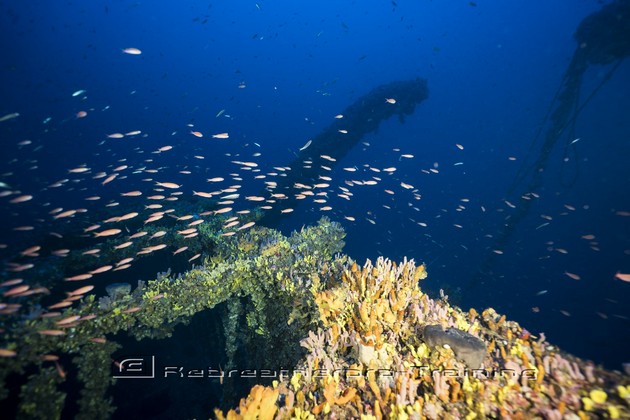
[{"left": 0, "top": 218, "right": 630, "bottom": 419}]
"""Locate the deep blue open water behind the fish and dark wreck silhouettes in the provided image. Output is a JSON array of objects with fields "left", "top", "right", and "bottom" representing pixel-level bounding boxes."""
[{"left": 0, "top": 0, "right": 630, "bottom": 414}]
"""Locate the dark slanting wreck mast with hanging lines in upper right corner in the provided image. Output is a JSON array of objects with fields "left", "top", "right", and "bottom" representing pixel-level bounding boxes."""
[{"left": 466, "top": 0, "right": 630, "bottom": 291}]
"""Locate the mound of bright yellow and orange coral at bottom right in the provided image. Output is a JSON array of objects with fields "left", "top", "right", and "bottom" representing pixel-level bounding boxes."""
[{"left": 215, "top": 258, "right": 630, "bottom": 419}]
